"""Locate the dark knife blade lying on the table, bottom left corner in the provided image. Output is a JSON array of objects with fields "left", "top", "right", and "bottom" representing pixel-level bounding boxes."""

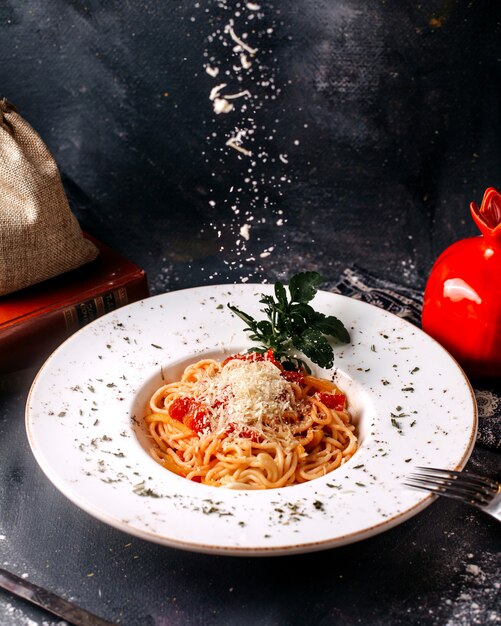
[{"left": 0, "top": 568, "right": 111, "bottom": 626}]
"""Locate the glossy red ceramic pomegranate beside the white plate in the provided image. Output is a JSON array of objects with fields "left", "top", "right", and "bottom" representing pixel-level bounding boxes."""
[{"left": 422, "top": 187, "right": 501, "bottom": 380}]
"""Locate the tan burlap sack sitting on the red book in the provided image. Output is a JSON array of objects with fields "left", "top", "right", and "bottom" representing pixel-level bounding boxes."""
[{"left": 0, "top": 99, "right": 98, "bottom": 296}]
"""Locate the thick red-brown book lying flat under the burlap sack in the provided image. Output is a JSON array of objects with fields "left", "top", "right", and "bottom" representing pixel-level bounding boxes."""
[{"left": 0, "top": 234, "right": 149, "bottom": 375}]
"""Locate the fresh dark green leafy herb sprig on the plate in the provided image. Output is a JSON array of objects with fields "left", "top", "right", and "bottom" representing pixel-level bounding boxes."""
[{"left": 228, "top": 272, "right": 350, "bottom": 371}]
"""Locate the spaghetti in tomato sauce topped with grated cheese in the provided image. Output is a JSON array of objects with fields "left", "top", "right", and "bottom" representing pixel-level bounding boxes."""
[{"left": 145, "top": 351, "right": 358, "bottom": 489}]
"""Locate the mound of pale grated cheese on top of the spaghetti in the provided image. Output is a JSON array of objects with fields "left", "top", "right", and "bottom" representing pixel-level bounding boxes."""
[{"left": 199, "top": 359, "right": 298, "bottom": 444}]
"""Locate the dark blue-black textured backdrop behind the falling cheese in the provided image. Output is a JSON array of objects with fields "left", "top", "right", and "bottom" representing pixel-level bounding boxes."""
[{"left": 0, "top": 0, "right": 501, "bottom": 291}]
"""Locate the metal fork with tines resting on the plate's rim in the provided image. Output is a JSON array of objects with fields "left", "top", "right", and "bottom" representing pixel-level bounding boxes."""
[{"left": 404, "top": 467, "right": 501, "bottom": 521}]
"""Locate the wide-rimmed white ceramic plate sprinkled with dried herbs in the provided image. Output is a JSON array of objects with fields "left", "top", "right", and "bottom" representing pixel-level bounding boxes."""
[{"left": 26, "top": 284, "right": 477, "bottom": 555}]
